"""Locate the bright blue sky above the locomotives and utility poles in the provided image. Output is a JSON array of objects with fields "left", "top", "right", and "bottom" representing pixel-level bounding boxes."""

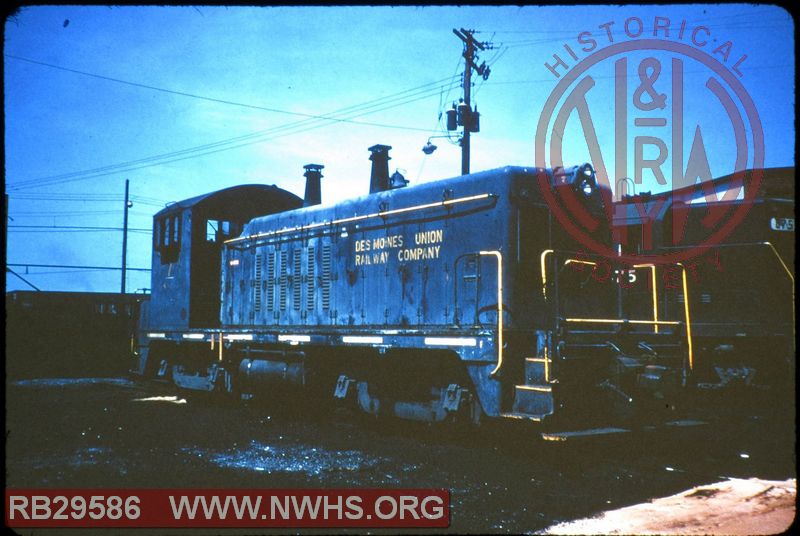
[{"left": 4, "top": 4, "right": 795, "bottom": 292}]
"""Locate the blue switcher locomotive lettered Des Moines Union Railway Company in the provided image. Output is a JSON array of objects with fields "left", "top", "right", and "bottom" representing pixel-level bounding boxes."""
[{"left": 137, "top": 145, "right": 693, "bottom": 427}]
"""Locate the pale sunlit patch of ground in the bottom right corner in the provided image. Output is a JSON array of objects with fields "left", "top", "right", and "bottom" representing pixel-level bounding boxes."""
[{"left": 544, "top": 478, "right": 797, "bottom": 535}]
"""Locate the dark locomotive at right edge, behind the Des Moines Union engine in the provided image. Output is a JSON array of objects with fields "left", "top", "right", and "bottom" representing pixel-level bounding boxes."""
[{"left": 614, "top": 168, "right": 795, "bottom": 394}]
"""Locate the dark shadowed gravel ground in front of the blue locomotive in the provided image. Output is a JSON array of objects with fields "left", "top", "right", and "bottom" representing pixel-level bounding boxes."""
[{"left": 6, "top": 378, "right": 796, "bottom": 535}]
